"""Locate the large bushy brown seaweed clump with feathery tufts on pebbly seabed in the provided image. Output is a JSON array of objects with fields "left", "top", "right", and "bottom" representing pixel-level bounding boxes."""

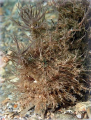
[{"left": 7, "top": 1, "right": 89, "bottom": 115}]
